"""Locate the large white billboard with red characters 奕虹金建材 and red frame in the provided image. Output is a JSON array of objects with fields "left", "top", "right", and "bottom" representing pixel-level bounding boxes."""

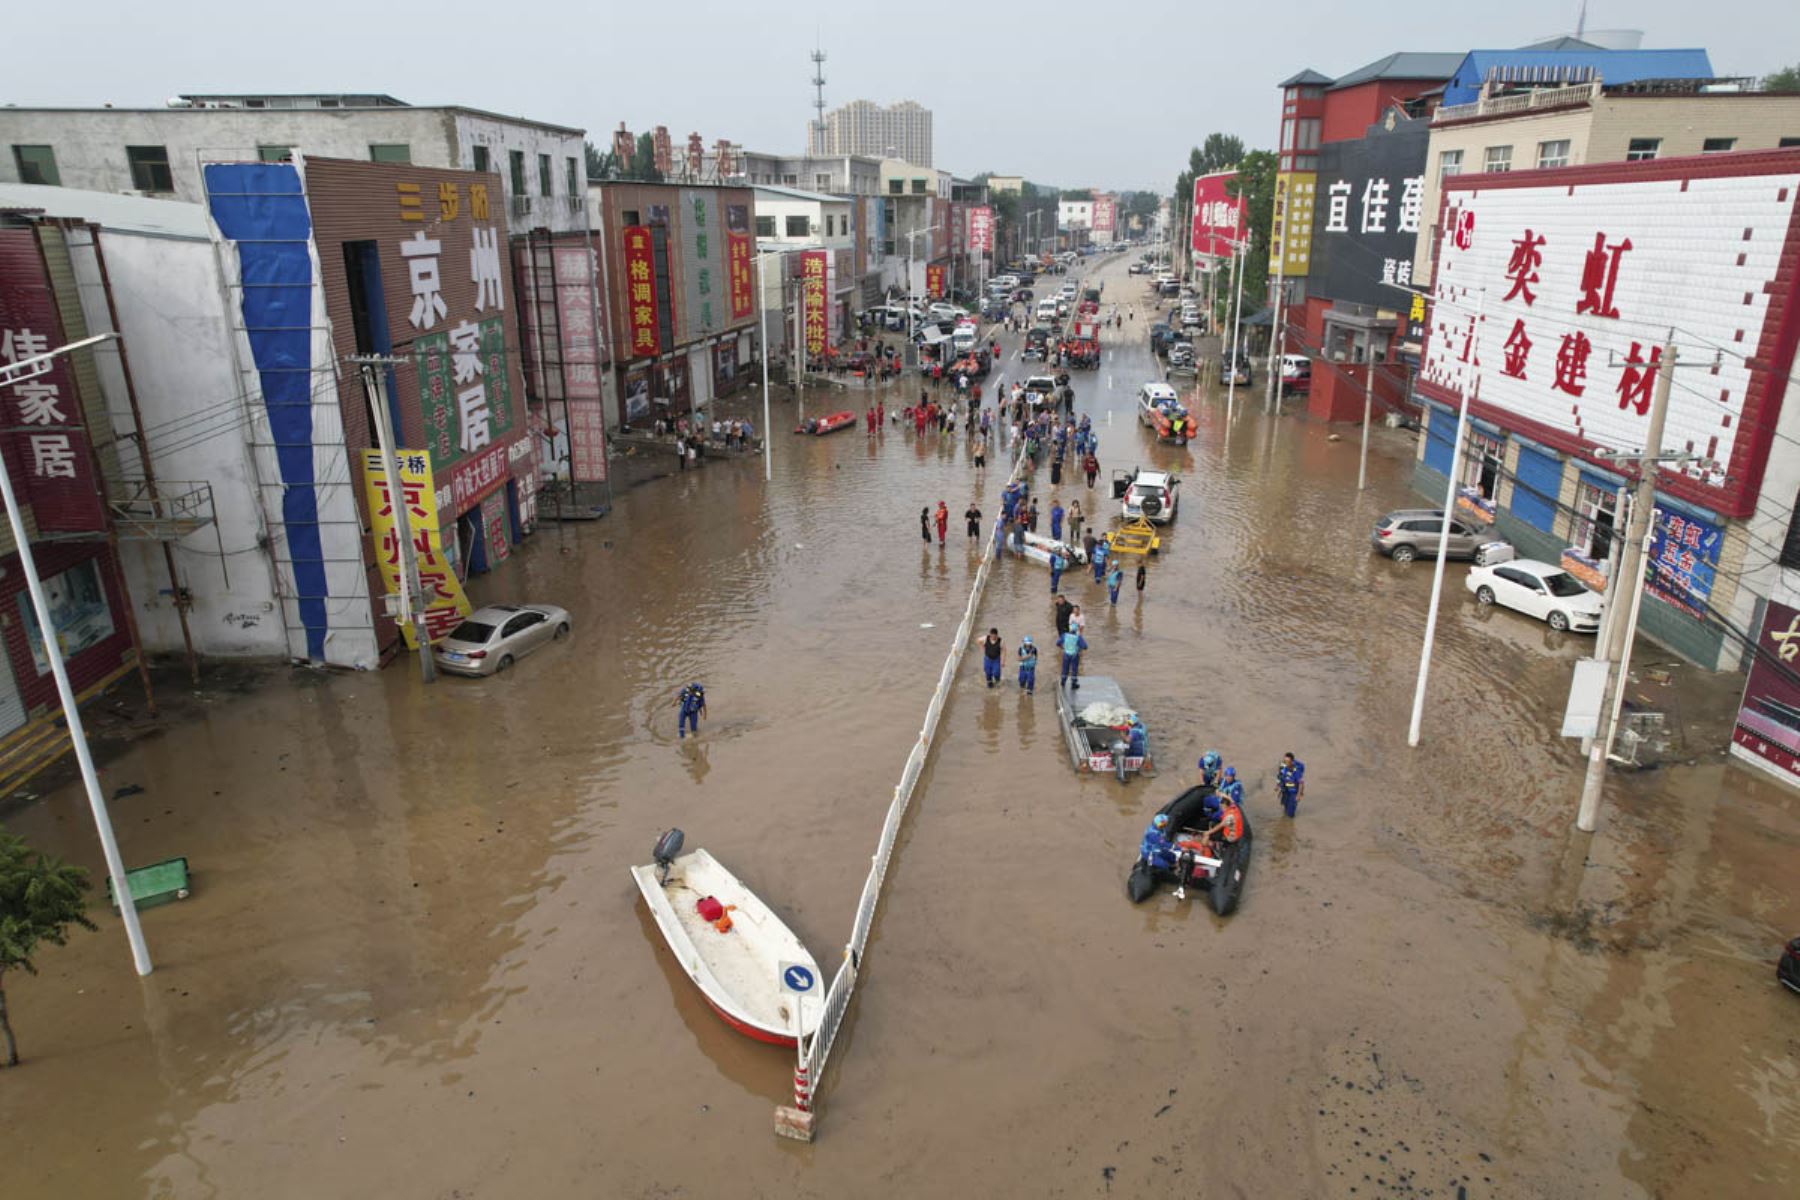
[{"left": 1420, "top": 151, "right": 1800, "bottom": 516}]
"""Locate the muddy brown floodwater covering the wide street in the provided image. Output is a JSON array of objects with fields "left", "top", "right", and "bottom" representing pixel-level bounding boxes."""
[{"left": 0, "top": 261, "right": 1800, "bottom": 1198}]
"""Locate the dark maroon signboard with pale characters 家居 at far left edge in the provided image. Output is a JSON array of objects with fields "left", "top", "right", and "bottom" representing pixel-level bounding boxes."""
[{"left": 0, "top": 228, "right": 106, "bottom": 533}]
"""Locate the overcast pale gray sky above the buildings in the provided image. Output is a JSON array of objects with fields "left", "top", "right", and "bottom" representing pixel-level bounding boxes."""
[{"left": 0, "top": 0, "right": 1800, "bottom": 191}]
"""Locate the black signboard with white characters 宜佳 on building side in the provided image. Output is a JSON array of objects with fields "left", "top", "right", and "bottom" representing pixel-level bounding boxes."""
[{"left": 1289, "top": 119, "right": 1431, "bottom": 309}]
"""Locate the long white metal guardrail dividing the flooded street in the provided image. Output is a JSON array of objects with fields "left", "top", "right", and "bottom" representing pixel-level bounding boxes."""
[{"left": 776, "top": 426, "right": 1026, "bottom": 1141}]
